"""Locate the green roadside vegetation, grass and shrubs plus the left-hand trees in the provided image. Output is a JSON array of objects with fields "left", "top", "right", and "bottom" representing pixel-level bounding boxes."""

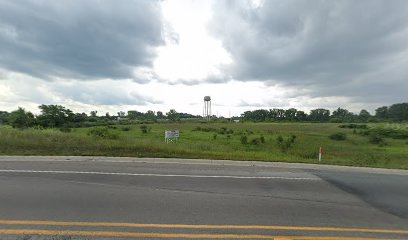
[{"left": 0, "top": 102, "right": 408, "bottom": 169}]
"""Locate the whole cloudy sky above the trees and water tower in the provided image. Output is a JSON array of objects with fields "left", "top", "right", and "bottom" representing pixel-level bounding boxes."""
[{"left": 0, "top": 0, "right": 408, "bottom": 117}]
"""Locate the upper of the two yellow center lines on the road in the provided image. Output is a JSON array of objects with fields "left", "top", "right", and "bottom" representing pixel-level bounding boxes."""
[{"left": 0, "top": 220, "right": 408, "bottom": 234}]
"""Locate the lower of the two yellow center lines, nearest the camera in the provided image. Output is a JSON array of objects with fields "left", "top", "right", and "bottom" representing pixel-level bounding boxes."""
[{"left": 0, "top": 229, "right": 394, "bottom": 240}]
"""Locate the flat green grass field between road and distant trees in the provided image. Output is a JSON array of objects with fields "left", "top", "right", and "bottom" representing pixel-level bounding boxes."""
[{"left": 0, "top": 122, "right": 408, "bottom": 169}]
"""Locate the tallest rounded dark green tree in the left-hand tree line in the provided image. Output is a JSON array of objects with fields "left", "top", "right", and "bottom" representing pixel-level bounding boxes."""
[{"left": 37, "top": 104, "right": 75, "bottom": 128}]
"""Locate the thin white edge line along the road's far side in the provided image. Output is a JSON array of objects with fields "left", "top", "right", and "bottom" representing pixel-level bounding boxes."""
[{"left": 0, "top": 169, "right": 321, "bottom": 180}]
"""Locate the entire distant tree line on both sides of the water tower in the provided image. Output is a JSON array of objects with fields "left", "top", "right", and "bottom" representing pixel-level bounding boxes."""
[{"left": 0, "top": 103, "right": 408, "bottom": 128}]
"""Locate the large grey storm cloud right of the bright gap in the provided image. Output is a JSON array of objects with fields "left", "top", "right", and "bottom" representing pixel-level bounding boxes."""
[{"left": 209, "top": 0, "right": 408, "bottom": 101}]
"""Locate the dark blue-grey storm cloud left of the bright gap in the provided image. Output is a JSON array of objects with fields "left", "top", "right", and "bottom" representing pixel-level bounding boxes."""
[{"left": 0, "top": 0, "right": 164, "bottom": 81}]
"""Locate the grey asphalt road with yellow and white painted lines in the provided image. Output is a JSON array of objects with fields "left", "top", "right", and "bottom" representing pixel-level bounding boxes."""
[{"left": 0, "top": 157, "right": 408, "bottom": 239}]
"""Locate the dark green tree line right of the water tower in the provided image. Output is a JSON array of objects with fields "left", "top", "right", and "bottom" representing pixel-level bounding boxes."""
[{"left": 241, "top": 103, "right": 408, "bottom": 122}]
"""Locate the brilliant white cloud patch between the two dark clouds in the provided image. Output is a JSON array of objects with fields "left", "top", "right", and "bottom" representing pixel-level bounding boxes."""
[{"left": 154, "top": 0, "right": 231, "bottom": 83}]
